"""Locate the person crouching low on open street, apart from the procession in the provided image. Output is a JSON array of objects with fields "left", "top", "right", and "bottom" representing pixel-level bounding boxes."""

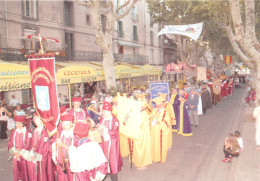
[{"left": 222, "top": 133, "right": 240, "bottom": 163}]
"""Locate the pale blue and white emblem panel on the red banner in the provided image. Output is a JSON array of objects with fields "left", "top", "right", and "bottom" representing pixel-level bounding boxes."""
[{"left": 35, "top": 86, "right": 50, "bottom": 111}]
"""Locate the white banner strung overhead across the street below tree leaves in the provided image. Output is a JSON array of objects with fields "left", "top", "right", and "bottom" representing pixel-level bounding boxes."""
[{"left": 158, "top": 22, "right": 203, "bottom": 41}]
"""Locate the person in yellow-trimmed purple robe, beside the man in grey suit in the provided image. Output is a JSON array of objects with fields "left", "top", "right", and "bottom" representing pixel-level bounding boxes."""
[{"left": 178, "top": 96, "right": 192, "bottom": 136}]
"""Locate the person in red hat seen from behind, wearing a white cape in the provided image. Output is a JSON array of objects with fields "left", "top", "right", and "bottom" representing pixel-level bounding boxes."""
[{"left": 56, "top": 122, "right": 107, "bottom": 181}]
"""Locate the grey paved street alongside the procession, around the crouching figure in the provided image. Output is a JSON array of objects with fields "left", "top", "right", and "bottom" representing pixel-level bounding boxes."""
[{"left": 0, "top": 89, "right": 260, "bottom": 181}]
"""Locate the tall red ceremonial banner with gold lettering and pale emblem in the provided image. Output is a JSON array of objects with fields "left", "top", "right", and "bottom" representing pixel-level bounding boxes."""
[{"left": 28, "top": 57, "right": 60, "bottom": 136}]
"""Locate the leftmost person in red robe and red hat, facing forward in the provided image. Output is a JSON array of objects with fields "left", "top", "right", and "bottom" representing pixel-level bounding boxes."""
[{"left": 8, "top": 116, "right": 32, "bottom": 181}]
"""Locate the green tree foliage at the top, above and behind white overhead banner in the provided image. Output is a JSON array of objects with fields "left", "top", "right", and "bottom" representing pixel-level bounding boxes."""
[{"left": 147, "top": 0, "right": 234, "bottom": 61}]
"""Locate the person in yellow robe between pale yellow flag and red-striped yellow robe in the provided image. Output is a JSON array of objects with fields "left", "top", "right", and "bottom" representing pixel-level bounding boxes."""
[{"left": 132, "top": 94, "right": 153, "bottom": 169}]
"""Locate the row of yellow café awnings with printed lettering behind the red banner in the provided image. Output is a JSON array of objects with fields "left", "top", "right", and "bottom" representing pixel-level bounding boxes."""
[{"left": 0, "top": 60, "right": 162, "bottom": 92}]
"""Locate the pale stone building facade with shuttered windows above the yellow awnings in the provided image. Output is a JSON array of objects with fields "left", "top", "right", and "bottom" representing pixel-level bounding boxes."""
[{"left": 0, "top": 0, "right": 176, "bottom": 65}]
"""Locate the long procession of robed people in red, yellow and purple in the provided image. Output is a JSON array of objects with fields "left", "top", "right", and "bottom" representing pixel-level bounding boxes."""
[{"left": 1, "top": 73, "right": 250, "bottom": 181}]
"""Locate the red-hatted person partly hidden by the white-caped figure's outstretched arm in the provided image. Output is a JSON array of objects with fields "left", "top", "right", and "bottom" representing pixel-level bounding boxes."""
[{"left": 52, "top": 114, "right": 74, "bottom": 181}]
